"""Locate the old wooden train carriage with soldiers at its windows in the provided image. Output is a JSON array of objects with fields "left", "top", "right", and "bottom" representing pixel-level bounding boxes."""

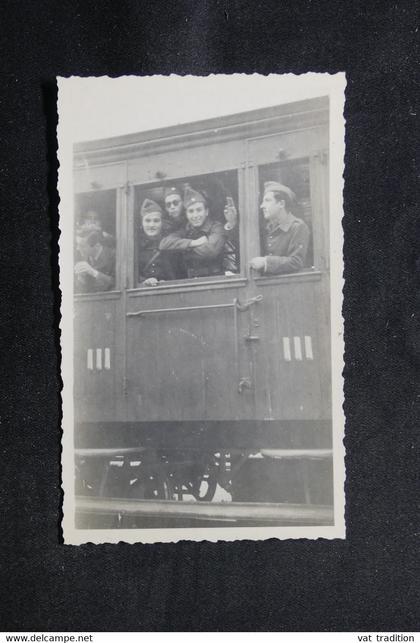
[{"left": 74, "top": 98, "right": 333, "bottom": 527}]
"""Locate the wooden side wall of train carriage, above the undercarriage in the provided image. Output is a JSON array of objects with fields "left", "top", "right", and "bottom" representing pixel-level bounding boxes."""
[{"left": 75, "top": 99, "right": 330, "bottom": 430}]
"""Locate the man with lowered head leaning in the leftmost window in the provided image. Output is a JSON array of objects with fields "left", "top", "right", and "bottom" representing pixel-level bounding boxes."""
[{"left": 74, "top": 231, "right": 115, "bottom": 293}]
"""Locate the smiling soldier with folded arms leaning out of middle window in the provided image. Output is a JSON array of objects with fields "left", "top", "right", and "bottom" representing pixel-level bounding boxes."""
[{"left": 160, "top": 187, "right": 236, "bottom": 278}]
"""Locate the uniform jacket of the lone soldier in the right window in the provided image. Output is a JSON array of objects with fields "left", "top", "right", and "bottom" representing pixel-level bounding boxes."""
[{"left": 264, "top": 215, "right": 310, "bottom": 275}]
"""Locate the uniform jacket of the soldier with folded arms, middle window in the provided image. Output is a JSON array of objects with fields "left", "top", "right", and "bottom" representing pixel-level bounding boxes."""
[{"left": 160, "top": 218, "right": 226, "bottom": 278}]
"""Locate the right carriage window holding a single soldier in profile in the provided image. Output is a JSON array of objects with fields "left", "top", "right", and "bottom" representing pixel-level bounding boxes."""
[{"left": 255, "top": 159, "right": 314, "bottom": 276}]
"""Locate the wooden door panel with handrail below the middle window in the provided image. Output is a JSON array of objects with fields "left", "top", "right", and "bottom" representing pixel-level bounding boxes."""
[{"left": 127, "top": 289, "right": 254, "bottom": 421}]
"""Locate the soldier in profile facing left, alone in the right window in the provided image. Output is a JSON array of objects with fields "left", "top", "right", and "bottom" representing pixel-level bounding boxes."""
[{"left": 250, "top": 181, "right": 310, "bottom": 275}]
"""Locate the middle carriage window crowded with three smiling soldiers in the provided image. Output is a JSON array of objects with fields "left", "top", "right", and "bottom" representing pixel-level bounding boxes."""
[{"left": 134, "top": 171, "right": 240, "bottom": 287}]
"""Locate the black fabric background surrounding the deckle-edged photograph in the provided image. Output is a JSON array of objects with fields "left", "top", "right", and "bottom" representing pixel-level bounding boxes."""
[{"left": 0, "top": 0, "right": 420, "bottom": 632}]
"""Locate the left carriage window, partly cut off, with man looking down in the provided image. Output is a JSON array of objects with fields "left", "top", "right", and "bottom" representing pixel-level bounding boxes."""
[{"left": 74, "top": 190, "right": 116, "bottom": 293}]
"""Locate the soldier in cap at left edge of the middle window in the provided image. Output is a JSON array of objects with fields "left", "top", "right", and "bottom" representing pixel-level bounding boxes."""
[{"left": 138, "top": 199, "right": 175, "bottom": 286}]
